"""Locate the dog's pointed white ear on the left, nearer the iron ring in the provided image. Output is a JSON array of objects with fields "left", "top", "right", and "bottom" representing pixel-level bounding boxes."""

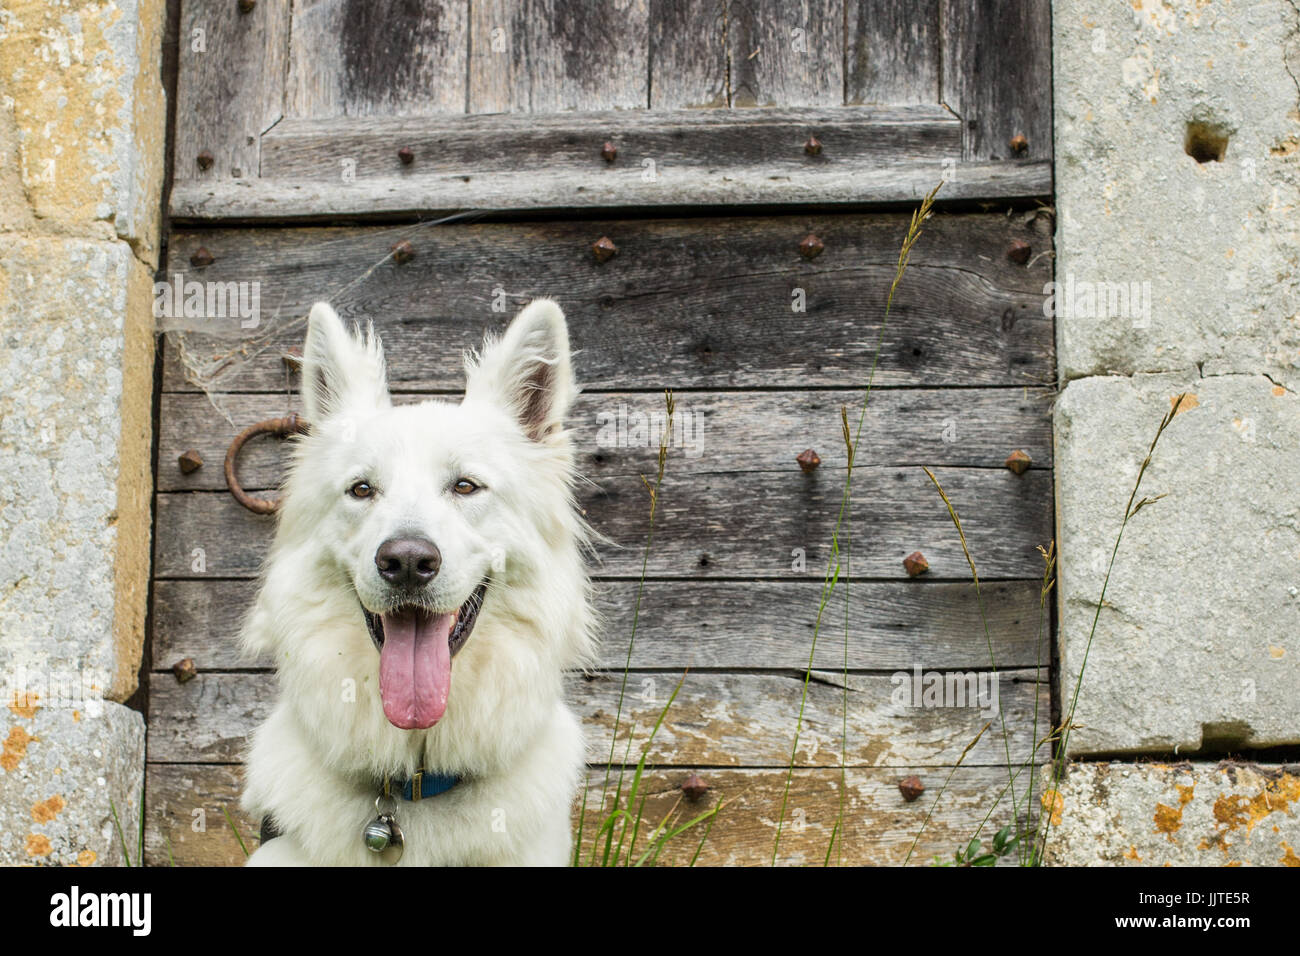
[{"left": 302, "top": 302, "right": 390, "bottom": 423}]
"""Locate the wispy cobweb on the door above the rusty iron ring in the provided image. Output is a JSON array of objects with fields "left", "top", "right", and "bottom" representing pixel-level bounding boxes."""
[{"left": 153, "top": 209, "right": 491, "bottom": 425}]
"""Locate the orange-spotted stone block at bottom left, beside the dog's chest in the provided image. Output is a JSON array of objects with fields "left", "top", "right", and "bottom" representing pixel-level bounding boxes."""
[{"left": 0, "top": 684, "right": 144, "bottom": 866}]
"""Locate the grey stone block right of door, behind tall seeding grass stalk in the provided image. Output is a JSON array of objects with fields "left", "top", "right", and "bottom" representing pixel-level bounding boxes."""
[{"left": 1056, "top": 375, "right": 1300, "bottom": 754}]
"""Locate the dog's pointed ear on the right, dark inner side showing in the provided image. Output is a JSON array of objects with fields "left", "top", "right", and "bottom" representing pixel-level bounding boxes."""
[{"left": 465, "top": 299, "right": 577, "bottom": 441}]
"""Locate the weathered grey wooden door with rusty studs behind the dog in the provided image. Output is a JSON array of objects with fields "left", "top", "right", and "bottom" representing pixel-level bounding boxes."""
[{"left": 146, "top": 0, "right": 1054, "bottom": 864}]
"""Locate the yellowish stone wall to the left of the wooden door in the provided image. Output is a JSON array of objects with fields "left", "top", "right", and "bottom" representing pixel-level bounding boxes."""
[{"left": 0, "top": 0, "right": 166, "bottom": 865}]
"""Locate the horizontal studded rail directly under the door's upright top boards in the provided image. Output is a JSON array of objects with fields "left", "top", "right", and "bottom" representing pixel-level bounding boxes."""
[{"left": 261, "top": 105, "right": 961, "bottom": 183}]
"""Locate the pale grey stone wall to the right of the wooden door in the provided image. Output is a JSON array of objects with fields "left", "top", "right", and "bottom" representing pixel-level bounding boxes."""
[{"left": 1049, "top": 0, "right": 1300, "bottom": 865}]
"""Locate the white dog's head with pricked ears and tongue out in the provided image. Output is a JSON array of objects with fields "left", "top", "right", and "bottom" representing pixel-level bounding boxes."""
[{"left": 267, "top": 299, "right": 581, "bottom": 730}]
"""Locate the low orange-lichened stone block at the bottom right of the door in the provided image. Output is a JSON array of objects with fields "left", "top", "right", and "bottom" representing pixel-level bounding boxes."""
[{"left": 1043, "top": 763, "right": 1300, "bottom": 866}]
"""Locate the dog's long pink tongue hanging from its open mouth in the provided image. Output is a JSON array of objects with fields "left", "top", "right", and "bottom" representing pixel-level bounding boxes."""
[{"left": 380, "top": 610, "right": 456, "bottom": 730}]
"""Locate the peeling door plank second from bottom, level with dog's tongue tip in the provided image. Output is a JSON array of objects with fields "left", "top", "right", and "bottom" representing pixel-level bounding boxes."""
[{"left": 150, "top": 658, "right": 1050, "bottom": 767}]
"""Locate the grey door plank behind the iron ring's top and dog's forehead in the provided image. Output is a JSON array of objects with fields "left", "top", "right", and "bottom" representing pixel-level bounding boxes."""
[{"left": 157, "top": 389, "right": 1056, "bottom": 492}]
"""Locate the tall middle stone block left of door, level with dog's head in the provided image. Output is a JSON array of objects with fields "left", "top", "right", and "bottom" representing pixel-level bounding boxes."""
[{"left": 0, "top": 238, "right": 153, "bottom": 700}]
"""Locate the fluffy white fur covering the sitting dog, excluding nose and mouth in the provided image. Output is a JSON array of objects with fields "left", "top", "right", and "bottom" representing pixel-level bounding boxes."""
[{"left": 242, "top": 299, "right": 594, "bottom": 866}]
